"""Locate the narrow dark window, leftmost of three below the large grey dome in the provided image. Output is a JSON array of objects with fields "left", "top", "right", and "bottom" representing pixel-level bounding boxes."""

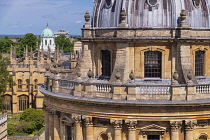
[{"left": 101, "top": 50, "right": 111, "bottom": 76}]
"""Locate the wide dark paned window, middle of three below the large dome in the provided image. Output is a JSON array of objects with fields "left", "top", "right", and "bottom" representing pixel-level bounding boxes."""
[{"left": 144, "top": 51, "right": 162, "bottom": 78}]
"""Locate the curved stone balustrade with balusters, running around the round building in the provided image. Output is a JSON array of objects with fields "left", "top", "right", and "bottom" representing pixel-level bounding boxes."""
[{"left": 45, "top": 76, "right": 210, "bottom": 101}]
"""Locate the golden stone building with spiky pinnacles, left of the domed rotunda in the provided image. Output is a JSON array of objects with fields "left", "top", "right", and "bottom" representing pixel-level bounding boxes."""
[{"left": 3, "top": 45, "right": 70, "bottom": 113}]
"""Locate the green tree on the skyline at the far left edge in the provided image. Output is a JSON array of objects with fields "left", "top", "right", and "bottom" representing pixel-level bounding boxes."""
[{"left": 0, "top": 36, "right": 14, "bottom": 53}]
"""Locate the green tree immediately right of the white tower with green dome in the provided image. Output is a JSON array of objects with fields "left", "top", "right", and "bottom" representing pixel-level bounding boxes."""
[{"left": 55, "top": 35, "right": 74, "bottom": 53}]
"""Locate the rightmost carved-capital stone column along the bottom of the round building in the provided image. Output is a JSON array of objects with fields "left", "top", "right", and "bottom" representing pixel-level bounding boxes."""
[{"left": 185, "top": 120, "right": 197, "bottom": 140}]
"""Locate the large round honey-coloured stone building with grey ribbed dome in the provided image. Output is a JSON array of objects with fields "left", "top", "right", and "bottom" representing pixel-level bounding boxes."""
[{"left": 39, "top": 0, "right": 210, "bottom": 140}]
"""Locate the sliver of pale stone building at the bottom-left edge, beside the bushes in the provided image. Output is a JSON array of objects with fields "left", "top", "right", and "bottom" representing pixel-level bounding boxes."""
[{"left": 0, "top": 114, "right": 7, "bottom": 140}]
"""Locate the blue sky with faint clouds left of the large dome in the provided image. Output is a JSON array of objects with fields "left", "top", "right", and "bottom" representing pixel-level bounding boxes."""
[{"left": 0, "top": 0, "right": 94, "bottom": 35}]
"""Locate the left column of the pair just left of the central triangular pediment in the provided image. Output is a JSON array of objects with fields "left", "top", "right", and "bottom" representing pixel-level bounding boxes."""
[{"left": 110, "top": 119, "right": 122, "bottom": 140}]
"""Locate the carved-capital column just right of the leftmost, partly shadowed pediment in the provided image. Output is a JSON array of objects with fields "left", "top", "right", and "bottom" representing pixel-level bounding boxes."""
[{"left": 72, "top": 115, "right": 83, "bottom": 140}]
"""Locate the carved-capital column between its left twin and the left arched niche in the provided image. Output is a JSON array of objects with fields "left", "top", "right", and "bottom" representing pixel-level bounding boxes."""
[{"left": 85, "top": 117, "right": 94, "bottom": 140}]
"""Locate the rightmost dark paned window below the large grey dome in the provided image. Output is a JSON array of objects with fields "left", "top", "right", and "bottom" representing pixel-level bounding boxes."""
[{"left": 195, "top": 51, "right": 205, "bottom": 76}]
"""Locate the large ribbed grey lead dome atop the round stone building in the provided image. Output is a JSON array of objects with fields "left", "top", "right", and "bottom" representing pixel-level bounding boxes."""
[{"left": 92, "top": 0, "right": 210, "bottom": 29}]
